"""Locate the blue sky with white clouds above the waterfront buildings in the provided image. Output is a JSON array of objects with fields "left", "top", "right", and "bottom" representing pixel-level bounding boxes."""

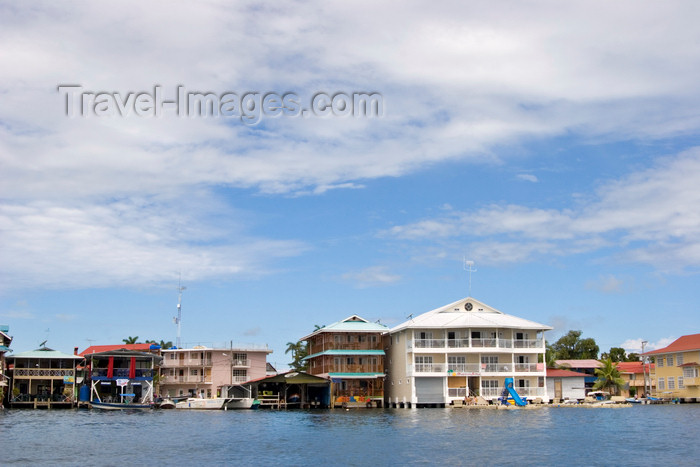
[{"left": 0, "top": 1, "right": 700, "bottom": 368}]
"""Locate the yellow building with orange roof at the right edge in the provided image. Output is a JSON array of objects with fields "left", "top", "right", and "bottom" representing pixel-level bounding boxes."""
[{"left": 644, "top": 334, "right": 700, "bottom": 402}]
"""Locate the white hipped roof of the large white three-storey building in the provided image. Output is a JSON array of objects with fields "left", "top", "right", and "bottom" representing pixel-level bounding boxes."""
[{"left": 390, "top": 297, "right": 552, "bottom": 333}]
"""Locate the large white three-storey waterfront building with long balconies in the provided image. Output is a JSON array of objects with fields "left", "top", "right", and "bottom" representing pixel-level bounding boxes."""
[{"left": 385, "top": 297, "right": 552, "bottom": 407}]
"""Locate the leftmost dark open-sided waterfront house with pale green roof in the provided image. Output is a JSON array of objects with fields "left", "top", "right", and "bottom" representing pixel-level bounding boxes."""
[{"left": 7, "top": 346, "right": 83, "bottom": 408}]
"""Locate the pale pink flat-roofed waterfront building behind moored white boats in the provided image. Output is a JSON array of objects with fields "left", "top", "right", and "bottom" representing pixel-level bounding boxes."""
[{"left": 159, "top": 344, "right": 272, "bottom": 399}]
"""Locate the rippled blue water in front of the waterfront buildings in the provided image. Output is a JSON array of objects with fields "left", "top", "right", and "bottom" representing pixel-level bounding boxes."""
[{"left": 0, "top": 405, "right": 700, "bottom": 466}]
